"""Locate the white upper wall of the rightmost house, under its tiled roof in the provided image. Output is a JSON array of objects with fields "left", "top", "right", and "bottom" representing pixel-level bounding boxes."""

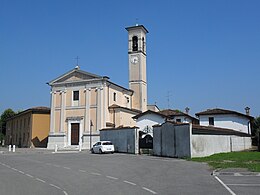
[{"left": 200, "top": 115, "right": 251, "bottom": 134}]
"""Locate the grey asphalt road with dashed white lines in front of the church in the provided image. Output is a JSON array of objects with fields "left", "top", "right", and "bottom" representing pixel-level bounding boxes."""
[{"left": 0, "top": 149, "right": 256, "bottom": 195}]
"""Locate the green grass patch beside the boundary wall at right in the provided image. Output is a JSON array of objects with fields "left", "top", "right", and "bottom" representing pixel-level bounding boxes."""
[{"left": 191, "top": 152, "right": 260, "bottom": 172}]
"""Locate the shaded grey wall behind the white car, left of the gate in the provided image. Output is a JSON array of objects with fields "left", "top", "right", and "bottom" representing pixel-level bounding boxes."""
[{"left": 100, "top": 128, "right": 139, "bottom": 154}]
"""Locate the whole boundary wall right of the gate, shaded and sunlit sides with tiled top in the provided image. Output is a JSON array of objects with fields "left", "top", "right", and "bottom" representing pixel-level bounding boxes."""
[{"left": 153, "top": 121, "right": 252, "bottom": 158}]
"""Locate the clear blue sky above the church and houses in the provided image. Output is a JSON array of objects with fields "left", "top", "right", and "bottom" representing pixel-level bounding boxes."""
[{"left": 0, "top": 0, "right": 260, "bottom": 116}]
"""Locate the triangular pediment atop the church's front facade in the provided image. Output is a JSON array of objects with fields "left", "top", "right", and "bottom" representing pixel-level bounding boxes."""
[{"left": 49, "top": 69, "right": 102, "bottom": 84}]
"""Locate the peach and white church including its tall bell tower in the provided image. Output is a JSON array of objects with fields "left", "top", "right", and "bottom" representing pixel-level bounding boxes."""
[{"left": 48, "top": 25, "right": 148, "bottom": 148}]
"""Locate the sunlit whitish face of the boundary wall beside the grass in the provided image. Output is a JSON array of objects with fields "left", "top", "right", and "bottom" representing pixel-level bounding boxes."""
[{"left": 191, "top": 135, "right": 251, "bottom": 157}]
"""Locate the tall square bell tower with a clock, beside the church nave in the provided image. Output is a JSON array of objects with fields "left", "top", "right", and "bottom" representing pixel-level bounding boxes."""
[{"left": 126, "top": 25, "right": 148, "bottom": 112}]
